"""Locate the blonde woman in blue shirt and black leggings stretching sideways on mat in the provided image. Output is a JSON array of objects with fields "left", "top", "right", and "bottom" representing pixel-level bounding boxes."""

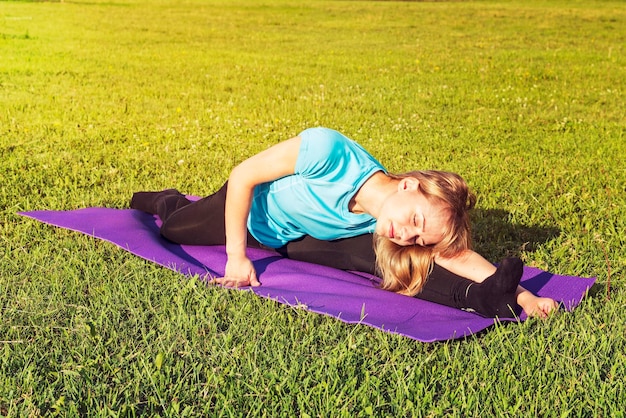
[{"left": 131, "top": 128, "right": 557, "bottom": 317}]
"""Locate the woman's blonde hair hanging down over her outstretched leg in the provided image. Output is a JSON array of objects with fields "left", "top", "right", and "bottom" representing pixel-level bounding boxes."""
[{"left": 374, "top": 170, "right": 476, "bottom": 296}]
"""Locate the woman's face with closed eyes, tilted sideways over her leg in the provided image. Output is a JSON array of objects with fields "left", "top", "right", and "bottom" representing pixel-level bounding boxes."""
[{"left": 376, "top": 179, "right": 448, "bottom": 246}]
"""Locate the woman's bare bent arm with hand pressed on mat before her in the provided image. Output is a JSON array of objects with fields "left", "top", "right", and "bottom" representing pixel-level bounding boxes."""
[{"left": 214, "top": 137, "right": 301, "bottom": 287}]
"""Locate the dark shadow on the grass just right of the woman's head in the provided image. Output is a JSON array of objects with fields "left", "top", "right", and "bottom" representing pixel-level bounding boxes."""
[{"left": 471, "top": 209, "right": 560, "bottom": 262}]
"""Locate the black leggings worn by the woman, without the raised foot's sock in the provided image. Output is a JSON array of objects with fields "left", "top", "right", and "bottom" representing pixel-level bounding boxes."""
[{"left": 131, "top": 183, "right": 512, "bottom": 312}]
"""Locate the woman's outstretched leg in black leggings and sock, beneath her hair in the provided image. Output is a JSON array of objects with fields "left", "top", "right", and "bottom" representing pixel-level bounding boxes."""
[{"left": 279, "top": 234, "right": 522, "bottom": 318}]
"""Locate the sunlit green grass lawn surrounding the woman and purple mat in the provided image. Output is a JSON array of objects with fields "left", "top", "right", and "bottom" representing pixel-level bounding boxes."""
[{"left": 0, "top": 0, "right": 626, "bottom": 417}]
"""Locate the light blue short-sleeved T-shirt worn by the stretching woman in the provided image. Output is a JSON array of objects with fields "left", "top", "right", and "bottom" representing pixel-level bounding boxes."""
[{"left": 248, "top": 128, "right": 386, "bottom": 248}]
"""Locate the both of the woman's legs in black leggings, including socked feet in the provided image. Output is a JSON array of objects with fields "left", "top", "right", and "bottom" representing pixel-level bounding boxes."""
[{"left": 131, "top": 189, "right": 521, "bottom": 317}]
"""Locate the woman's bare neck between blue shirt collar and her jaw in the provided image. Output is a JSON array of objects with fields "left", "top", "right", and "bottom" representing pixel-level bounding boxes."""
[{"left": 350, "top": 171, "right": 399, "bottom": 218}]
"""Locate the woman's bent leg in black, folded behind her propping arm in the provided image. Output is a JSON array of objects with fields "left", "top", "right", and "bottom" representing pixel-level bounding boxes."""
[{"left": 131, "top": 183, "right": 260, "bottom": 248}]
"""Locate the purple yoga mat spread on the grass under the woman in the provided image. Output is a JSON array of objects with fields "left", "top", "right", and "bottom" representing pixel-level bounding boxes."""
[{"left": 20, "top": 208, "right": 595, "bottom": 342}]
